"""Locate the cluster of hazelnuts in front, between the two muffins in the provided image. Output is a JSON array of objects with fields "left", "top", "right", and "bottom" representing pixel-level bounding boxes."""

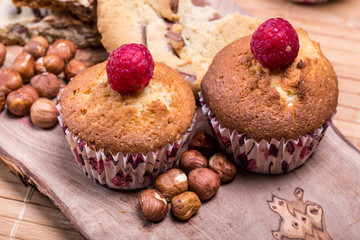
[{"left": 139, "top": 130, "right": 237, "bottom": 221}]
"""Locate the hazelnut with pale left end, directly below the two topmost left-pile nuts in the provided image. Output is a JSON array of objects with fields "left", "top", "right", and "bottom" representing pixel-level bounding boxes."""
[{"left": 35, "top": 55, "right": 65, "bottom": 75}]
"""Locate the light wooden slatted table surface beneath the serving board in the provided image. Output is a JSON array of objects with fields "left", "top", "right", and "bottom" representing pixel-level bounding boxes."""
[{"left": 0, "top": 0, "right": 360, "bottom": 239}]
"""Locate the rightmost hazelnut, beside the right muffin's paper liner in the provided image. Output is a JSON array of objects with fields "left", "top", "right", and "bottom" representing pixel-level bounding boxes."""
[{"left": 209, "top": 153, "right": 237, "bottom": 182}]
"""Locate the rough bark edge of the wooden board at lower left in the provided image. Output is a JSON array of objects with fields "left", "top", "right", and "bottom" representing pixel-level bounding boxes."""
[{"left": 0, "top": 146, "right": 88, "bottom": 239}]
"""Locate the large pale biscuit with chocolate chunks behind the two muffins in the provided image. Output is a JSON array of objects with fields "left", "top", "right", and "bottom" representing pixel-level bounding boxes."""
[{"left": 97, "top": 0, "right": 260, "bottom": 96}]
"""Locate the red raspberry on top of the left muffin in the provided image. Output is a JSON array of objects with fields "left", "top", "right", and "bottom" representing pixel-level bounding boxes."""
[{"left": 106, "top": 43, "right": 154, "bottom": 94}]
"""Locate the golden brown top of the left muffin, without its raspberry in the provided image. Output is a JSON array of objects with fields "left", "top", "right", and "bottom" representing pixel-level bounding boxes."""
[{"left": 61, "top": 62, "right": 195, "bottom": 154}]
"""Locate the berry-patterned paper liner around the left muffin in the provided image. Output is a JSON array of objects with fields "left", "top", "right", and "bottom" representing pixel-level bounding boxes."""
[{"left": 56, "top": 104, "right": 195, "bottom": 190}]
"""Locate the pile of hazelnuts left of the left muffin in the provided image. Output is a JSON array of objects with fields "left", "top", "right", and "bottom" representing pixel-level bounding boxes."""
[{"left": 0, "top": 36, "right": 86, "bottom": 128}]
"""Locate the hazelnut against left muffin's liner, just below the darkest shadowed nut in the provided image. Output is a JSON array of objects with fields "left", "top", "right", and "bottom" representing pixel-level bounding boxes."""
[{"left": 179, "top": 150, "right": 208, "bottom": 174}]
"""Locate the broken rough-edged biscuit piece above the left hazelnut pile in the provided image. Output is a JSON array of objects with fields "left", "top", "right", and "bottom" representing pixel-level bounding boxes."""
[{"left": 0, "top": 0, "right": 101, "bottom": 48}]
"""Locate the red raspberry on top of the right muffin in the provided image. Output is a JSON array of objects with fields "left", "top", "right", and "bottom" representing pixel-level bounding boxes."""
[{"left": 250, "top": 18, "right": 299, "bottom": 68}]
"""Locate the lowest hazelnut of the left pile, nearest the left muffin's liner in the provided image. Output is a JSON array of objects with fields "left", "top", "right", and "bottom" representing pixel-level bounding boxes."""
[{"left": 30, "top": 98, "right": 59, "bottom": 128}]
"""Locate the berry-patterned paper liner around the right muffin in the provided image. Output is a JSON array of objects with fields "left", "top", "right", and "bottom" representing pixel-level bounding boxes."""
[{"left": 199, "top": 92, "right": 335, "bottom": 174}]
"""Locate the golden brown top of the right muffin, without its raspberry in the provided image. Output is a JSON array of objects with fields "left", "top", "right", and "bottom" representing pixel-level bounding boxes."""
[{"left": 201, "top": 29, "right": 338, "bottom": 142}]
